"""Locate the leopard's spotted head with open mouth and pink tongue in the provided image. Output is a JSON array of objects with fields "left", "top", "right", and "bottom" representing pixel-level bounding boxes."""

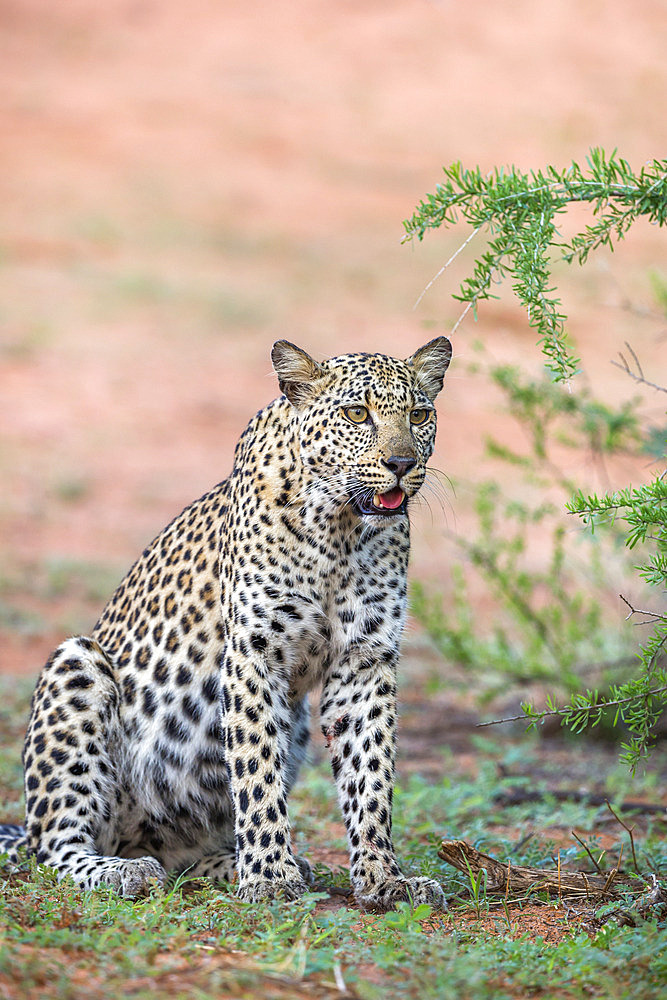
[{"left": 271, "top": 337, "right": 452, "bottom": 522}]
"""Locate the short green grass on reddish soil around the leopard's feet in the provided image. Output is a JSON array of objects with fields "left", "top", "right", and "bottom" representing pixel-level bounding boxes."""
[{"left": 0, "top": 683, "right": 667, "bottom": 1000}]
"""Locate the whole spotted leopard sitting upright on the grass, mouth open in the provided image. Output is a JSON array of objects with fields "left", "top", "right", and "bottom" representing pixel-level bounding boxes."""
[{"left": 0, "top": 336, "right": 452, "bottom": 910}]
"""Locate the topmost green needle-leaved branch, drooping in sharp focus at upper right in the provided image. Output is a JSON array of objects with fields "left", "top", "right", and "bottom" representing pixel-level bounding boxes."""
[{"left": 404, "top": 149, "right": 667, "bottom": 381}]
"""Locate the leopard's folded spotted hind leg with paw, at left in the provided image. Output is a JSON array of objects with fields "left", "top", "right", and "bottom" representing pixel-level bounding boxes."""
[{"left": 24, "top": 637, "right": 166, "bottom": 898}]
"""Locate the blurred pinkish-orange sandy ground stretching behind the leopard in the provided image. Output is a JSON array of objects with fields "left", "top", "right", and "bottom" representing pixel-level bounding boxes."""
[{"left": 0, "top": 0, "right": 667, "bottom": 673}]
